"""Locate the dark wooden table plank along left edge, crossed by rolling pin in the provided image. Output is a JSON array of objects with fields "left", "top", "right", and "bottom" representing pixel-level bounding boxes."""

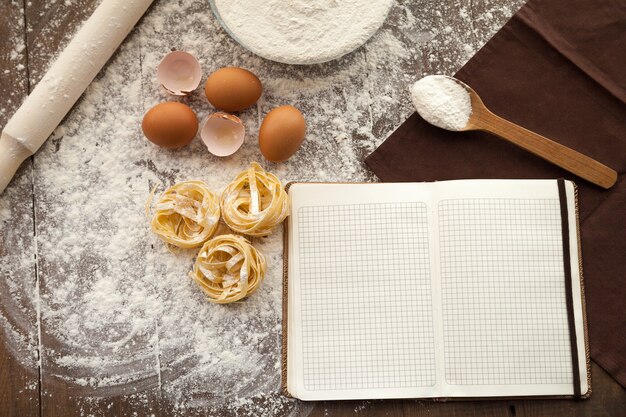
[{"left": 0, "top": 1, "right": 39, "bottom": 416}]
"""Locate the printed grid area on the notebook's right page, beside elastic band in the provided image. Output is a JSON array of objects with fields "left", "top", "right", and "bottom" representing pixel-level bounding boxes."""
[{"left": 438, "top": 199, "right": 572, "bottom": 385}]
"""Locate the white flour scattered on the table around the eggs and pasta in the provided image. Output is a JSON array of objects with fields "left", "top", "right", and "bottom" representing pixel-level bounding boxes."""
[{"left": 0, "top": 0, "right": 521, "bottom": 416}]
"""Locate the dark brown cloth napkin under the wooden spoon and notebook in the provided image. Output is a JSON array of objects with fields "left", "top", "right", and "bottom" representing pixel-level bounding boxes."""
[{"left": 365, "top": 0, "right": 626, "bottom": 387}]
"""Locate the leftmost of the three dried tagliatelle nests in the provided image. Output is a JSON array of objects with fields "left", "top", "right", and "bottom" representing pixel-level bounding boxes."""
[{"left": 148, "top": 181, "right": 220, "bottom": 248}]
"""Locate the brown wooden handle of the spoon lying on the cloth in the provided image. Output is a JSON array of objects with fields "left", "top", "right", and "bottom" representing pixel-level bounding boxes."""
[{"left": 477, "top": 112, "right": 617, "bottom": 188}]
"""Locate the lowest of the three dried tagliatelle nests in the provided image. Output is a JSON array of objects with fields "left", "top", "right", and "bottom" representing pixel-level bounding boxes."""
[{"left": 190, "top": 235, "right": 265, "bottom": 304}]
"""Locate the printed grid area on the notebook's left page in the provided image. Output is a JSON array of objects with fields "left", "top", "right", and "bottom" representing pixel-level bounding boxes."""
[{"left": 298, "top": 203, "right": 435, "bottom": 391}]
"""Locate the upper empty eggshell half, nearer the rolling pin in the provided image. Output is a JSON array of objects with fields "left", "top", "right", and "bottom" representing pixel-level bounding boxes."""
[{"left": 157, "top": 51, "right": 202, "bottom": 96}]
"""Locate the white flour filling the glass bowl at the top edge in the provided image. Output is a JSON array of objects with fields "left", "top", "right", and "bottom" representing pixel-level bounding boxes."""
[{"left": 214, "top": 0, "right": 392, "bottom": 64}]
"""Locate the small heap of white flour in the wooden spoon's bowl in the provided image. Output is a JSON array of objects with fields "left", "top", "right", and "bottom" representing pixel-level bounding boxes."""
[{"left": 411, "top": 75, "right": 472, "bottom": 131}]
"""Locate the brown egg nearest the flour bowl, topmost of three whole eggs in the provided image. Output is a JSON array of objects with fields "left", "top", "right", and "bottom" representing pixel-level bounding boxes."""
[{"left": 204, "top": 67, "right": 263, "bottom": 112}]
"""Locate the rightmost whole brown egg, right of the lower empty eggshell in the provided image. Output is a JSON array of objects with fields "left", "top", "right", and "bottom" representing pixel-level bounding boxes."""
[{"left": 259, "top": 106, "right": 306, "bottom": 162}]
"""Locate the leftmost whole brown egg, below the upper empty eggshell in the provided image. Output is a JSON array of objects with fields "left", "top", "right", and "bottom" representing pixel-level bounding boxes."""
[{"left": 141, "top": 101, "right": 198, "bottom": 148}]
